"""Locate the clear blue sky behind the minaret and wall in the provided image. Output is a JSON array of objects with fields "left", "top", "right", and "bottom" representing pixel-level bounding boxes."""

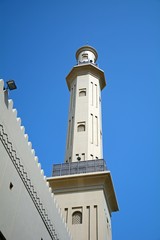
[{"left": 0, "top": 0, "right": 160, "bottom": 240}]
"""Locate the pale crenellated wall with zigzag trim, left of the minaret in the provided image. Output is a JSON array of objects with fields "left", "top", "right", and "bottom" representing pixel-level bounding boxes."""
[{"left": 0, "top": 80, "right": 71, "bottom": 240}]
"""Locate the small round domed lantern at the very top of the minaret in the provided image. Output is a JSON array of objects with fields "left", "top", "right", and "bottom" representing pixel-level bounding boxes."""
[{"left": 76, "top": 45, "right": 98, "bottom": 64}]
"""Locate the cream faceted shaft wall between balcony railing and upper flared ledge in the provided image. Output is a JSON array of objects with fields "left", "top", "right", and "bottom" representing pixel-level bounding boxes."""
[{"left": 65, "top": 74, "right": 103, "bottom": 162}]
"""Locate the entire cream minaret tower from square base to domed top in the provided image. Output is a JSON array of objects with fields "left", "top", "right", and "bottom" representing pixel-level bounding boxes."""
[{"left": 47, "top": 46, "right": 118, "bottom": 240}]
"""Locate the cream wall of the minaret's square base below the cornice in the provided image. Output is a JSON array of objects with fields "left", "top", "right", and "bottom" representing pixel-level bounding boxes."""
[{"left": 55, "top": 189, "right": 112, "bottom": 240}]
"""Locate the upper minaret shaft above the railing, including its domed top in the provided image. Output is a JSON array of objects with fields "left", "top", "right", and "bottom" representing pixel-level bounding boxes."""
[{"left": 65, "top": 46, "right": 106, "bottom": 162}]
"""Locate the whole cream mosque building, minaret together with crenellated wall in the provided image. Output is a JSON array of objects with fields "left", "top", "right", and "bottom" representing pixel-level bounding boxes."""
[{"left": 0, "top": 46, "right": 119, "bottom": 240}]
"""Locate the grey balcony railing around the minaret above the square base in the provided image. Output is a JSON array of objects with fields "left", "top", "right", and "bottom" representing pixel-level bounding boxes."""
[{"left": 52, "top": 159, "right": 107, "bottom": 177}]
